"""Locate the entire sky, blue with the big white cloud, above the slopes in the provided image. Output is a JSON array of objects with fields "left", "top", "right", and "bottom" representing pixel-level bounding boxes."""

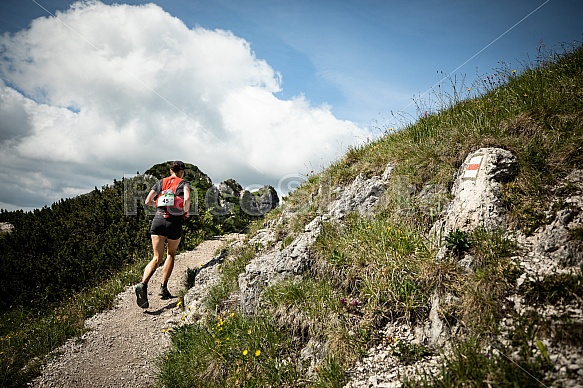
[{"left": 0, "top": 0, "right": 583, "bottom": 209}]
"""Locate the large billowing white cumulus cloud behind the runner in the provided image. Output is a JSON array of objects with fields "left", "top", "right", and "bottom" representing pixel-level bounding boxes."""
[{"left": 0, "top": 2, "right": 366, "bottom": 208}]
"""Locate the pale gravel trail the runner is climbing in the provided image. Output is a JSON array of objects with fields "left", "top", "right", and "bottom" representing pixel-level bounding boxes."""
[{"left": 32, "top": 235, "right": 243, "bottom": 388}]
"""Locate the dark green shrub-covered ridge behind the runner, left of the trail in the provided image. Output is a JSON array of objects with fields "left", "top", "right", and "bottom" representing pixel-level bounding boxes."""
[{"left": 0, "top": 162, "right": 278, "bottom": 313}]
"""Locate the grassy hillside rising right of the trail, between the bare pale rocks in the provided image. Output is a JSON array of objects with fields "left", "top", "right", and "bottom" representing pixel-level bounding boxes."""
[{"left": 161, "top": 47, "right": 583, "bottom": 387}]
